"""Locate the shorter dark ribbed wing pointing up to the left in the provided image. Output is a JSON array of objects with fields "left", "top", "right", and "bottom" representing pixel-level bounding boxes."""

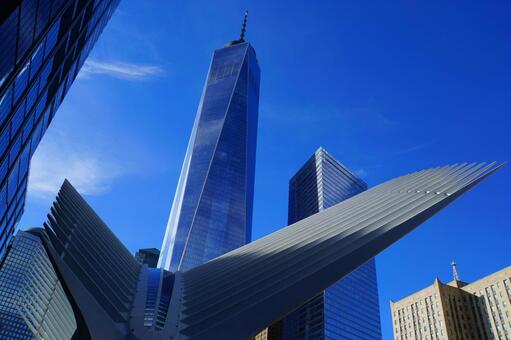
[{"left": 44, "top": 180, "right": 140, "bottom": 322}]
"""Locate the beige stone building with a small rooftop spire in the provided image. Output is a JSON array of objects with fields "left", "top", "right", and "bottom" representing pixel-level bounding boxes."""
[{"left": 390, "top": 267, "right": 511, "bottom": 340}]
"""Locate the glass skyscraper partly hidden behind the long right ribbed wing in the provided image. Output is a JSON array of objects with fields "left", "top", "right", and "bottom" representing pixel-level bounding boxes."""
[{"left": 282, "top": 148, "right": 381, "bottom": 340}]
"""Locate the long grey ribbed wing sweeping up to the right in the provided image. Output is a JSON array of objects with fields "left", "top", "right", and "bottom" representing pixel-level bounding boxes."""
[{"left": 178, "top": 163, "right": 504, "bottom": 339}]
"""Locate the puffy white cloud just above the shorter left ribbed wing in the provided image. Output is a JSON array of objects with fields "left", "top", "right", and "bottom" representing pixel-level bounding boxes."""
[{"left": 28, "top": 130, "right": 124, "bottom": 200}]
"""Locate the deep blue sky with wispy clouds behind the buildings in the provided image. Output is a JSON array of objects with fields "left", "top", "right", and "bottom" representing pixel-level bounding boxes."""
[{"left": 20, "top": 0, "right": 511, "bottom": 339}]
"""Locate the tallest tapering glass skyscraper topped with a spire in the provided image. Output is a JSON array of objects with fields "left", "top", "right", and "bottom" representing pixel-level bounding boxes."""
[{"left": 158, "top": 14, "right": 260, "bottom": 272}]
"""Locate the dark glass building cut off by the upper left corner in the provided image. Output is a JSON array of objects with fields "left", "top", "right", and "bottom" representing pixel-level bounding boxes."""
[{"left": 0, "top": 0, "right": 119, "bottom": 258}]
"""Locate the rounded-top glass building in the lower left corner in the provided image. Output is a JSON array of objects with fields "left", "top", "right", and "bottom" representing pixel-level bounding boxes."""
[{"left": 0, "top": 231, "right": 76, "bottom": 339}]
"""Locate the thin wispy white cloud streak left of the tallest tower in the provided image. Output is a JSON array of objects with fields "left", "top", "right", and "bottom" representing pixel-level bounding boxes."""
[{"left": 78, "top": 59, "right": 164, "bottom": 81}]
